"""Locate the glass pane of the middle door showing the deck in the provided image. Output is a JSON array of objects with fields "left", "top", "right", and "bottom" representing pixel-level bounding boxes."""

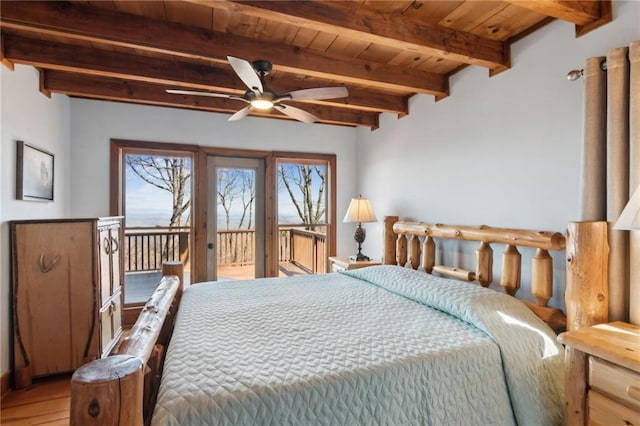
[{"left": 216, "top": 167, "right": 256, "bottom": 280}]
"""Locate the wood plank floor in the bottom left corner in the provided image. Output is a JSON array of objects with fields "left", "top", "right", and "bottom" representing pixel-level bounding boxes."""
[{"left": 0, "top": 376, "right": 71, "bottom": 426}]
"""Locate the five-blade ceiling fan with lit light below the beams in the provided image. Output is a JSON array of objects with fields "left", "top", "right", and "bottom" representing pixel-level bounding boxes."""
[{"left": 162, "top": 56, "right": 349, "bottom": 123}]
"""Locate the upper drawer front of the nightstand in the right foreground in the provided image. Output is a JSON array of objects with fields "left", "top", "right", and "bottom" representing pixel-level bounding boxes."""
[{"left": 589, "top": 357, "right": 640, "bottom": 410}]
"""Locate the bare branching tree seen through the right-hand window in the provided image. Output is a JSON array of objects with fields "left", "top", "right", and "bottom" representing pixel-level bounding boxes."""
[{"left": 278, "top": 164, "right": 326, "bottom": 224}]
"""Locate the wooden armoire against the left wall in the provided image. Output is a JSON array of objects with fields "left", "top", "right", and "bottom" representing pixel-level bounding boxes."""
[{"left": 10, "top": 217, "right": 124, "bottom": 388}]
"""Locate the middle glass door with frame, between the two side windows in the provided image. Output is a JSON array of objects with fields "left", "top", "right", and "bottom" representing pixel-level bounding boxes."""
[{"left": 206, "top": 155, "right": 265, "bottom": 281}]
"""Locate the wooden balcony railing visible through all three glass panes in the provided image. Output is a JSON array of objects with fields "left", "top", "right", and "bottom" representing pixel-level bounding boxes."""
[{"left": 125, "top": 225, "right": 326, "bottom": 274}]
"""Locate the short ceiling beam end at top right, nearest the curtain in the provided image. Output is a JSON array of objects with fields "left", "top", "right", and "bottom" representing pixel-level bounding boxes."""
[{"left": 508, "top": 0, "right": 613, "bottom": 37}]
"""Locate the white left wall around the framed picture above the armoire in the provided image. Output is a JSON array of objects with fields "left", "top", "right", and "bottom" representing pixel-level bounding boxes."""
[{"left": 0, "top": 65, "right": 70, "bottom": 374}]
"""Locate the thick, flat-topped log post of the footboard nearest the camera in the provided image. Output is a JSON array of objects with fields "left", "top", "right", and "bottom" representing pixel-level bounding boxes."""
[{"left": 69, "top": 355, "right": 144, "bottom": 426}]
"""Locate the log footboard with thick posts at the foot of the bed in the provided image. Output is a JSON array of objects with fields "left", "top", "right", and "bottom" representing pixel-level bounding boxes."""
[{"left": 70, "top": 262, "right": 183, "bottom": 426}]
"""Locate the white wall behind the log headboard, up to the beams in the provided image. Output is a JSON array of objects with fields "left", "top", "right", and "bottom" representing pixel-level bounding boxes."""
[{"left": 358, "top": 2, "right": 640, "bottom": 306}]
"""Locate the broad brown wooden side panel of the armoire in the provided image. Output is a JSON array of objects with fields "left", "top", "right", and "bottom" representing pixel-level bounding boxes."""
[{"left": 12, "top": 222, "right": 98, "bottom": 376}]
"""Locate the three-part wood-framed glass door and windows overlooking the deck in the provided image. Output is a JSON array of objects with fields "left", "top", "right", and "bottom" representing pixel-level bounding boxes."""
[{"left": 110, "top": 139, "right": 336, "bottom": 304}]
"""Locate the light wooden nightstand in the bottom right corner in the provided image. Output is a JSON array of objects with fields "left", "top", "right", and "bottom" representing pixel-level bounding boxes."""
[{"left": 558, "top": 322, "right": 640, "bottom": 425}]
